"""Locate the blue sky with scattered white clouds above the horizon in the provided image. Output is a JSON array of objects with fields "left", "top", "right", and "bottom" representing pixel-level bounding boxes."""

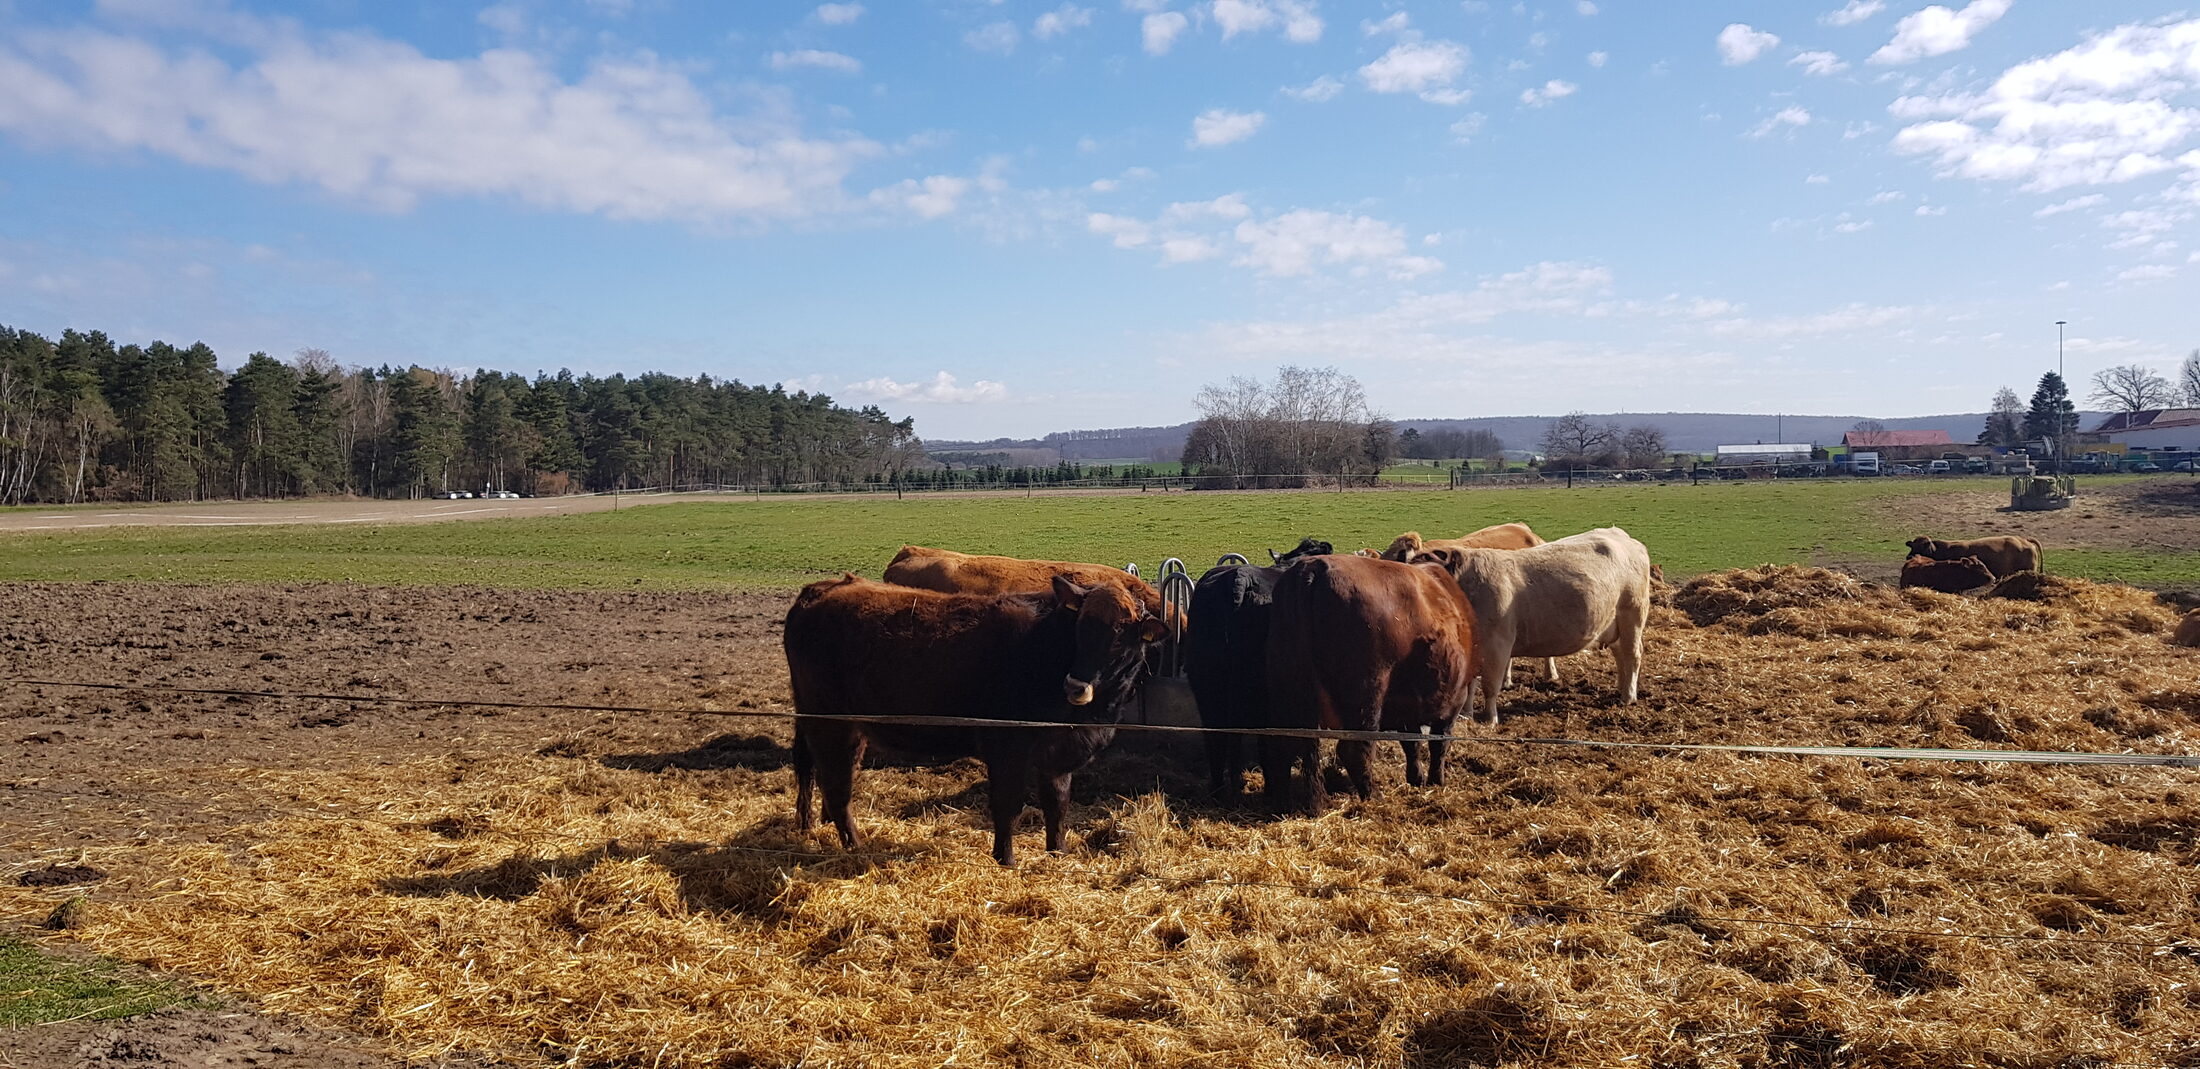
[{"left": 0, "top": 0, "right": 2200, "bottom": 438}]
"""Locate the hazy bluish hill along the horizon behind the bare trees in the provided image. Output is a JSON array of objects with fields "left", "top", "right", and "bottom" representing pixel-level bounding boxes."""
[{"left": 924, "top": 411, "right": 2105, "bottom": 464}]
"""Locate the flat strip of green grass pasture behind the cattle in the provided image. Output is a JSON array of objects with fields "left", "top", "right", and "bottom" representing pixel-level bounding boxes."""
[{"left": 0, "top": 480, "right": 2200, "bottom": 589}]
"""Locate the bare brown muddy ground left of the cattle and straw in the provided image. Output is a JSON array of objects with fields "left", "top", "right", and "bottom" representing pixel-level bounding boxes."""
[{"left": 0, "top": 583, "right": 788, "bottom": 1069}]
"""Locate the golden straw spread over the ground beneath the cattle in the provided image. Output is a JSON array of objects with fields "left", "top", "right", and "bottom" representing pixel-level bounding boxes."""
[{"left": 0, "top": 567, "right": 2200, "bottom": 1069}]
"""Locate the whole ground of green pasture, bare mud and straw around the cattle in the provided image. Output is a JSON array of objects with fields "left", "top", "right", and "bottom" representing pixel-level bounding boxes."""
[{"left": 0, "top": 484, "right": 2200, "bottom": 1069}]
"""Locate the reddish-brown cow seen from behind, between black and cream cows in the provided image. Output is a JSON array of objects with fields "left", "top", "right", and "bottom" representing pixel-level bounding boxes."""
[{"left": 1261, "top": 556, "right": 1487, "bottom": 814}]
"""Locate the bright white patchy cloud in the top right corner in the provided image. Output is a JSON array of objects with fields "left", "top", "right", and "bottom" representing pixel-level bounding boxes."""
[{"left": 1888, "top": 17, "right": 2200, "bottom": 191}]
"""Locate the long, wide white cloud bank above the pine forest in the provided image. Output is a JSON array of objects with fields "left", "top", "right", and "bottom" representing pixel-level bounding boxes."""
[{"left": 0, "top": 15, "right": 882, "bottom": 220}]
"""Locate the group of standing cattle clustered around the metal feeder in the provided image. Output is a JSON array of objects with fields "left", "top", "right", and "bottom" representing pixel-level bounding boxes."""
[{"left": 785, "top": 524, "right": 1654, "bottom": 864}]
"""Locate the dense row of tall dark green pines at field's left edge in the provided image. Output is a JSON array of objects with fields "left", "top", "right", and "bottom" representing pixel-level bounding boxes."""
[{"left": 0, "top": 326, "right": 924, "bottom": 504}]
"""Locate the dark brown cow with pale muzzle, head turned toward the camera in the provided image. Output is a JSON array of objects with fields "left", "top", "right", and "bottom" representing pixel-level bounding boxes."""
[{"left": 785, "top": 576, "right": 1162, "bottom": 864}]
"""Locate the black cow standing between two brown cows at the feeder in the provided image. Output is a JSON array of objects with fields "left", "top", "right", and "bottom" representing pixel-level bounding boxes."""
[{"left": 1184, "top": 539, "right": 1335, "bottom": 794}]
